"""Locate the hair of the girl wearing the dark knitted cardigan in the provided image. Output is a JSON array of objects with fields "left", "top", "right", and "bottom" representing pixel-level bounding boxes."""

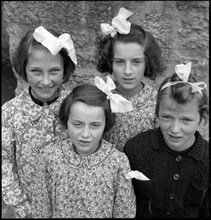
[{"left": 155, "top": 73, "right": 209, "bottom": 122}]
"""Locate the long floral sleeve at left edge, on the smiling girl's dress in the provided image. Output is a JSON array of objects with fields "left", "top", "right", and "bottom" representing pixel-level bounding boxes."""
[{"left": 2, "top": 106, "right": 31, "bottom": 218}]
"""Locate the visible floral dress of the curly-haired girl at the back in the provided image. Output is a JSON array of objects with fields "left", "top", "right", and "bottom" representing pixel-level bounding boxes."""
[{"left": 104, "top": 84, "right": 158, "bottom": 151}]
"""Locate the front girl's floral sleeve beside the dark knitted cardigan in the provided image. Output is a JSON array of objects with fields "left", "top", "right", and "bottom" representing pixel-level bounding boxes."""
[{"left": 113, "top": 153, "right": 136, "bottom": 218}]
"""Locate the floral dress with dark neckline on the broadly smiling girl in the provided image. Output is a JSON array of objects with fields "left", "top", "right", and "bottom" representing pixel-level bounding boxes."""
[{"left": 2, "top": 86, "right": 70, "bottom": 218}]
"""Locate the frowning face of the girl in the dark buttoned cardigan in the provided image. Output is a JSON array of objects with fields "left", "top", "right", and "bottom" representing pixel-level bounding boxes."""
[{"left": 159, "top": 96, "right": 200, "bottom": 151}]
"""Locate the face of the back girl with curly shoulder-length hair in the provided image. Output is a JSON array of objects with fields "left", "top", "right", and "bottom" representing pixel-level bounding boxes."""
[{"left": 112, "top": 42, "right": 146, "bottom": 95}]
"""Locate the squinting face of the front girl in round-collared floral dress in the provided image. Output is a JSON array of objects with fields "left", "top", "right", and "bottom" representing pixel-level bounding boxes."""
[{"left": 67, "top": 101, "right": 106, "bottom": 156}]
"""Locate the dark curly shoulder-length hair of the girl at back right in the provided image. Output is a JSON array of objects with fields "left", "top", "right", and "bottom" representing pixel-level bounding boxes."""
[{"left": 96, "top": 24, "right": 165, "bottom": 79}]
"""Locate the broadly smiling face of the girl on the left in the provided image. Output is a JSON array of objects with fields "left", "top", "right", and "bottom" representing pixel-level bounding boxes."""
[{"left": 26, "top": 49, "right": 64, "bottom": 102}]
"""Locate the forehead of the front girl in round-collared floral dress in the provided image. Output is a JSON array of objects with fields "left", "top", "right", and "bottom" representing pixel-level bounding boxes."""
[{"left": 69, "top": 101, "right": 105, "bottom": 122}]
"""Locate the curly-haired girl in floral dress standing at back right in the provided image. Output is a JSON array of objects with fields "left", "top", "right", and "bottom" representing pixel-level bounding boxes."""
[{"left": 96, "top": 8, "right": 164, "bottom": 151}]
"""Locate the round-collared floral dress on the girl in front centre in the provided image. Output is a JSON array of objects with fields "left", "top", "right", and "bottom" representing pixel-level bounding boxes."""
[{"left": 34, "top": 138, "right": 136, "bottom": 218}]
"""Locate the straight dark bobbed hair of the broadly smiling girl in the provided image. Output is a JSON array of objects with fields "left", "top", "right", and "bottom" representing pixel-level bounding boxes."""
[{"left": 12, "top": 26, "right": 75, "bottom": 83}]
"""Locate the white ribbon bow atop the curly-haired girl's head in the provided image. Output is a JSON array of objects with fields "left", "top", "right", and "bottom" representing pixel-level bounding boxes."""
[{"left": 100, "top": 8, "right": 133, "bottom": 37}]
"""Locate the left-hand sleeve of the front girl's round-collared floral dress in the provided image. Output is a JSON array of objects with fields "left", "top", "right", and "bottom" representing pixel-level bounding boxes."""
[{"left": 32, "top": 145, "right": 53, "bottom": 218}]
